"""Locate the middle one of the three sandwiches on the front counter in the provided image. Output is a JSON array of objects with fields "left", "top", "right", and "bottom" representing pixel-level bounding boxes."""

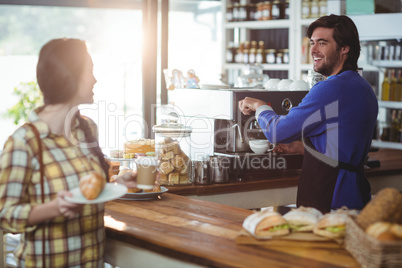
[{"left": 283, "top": 207, "right": 322, "bottom": 232}]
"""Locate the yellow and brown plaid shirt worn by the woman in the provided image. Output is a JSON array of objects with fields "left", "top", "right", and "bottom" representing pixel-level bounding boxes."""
[{"left": 0, "top": 108, "right": 105, "bottom": 268}]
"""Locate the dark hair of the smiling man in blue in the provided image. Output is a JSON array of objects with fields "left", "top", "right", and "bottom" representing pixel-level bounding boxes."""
[{"left": 307, "top": 14, "right": 360, "bottom": 72}]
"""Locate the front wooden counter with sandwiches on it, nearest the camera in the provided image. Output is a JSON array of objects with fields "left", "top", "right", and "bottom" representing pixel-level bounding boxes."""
[{"left": 105, "top": 193, "right": 358, "bottom": 268}]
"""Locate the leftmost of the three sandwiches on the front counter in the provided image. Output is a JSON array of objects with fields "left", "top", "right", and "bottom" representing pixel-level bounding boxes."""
[{"left": 243, "top": 211, "right": 289, "bottom": 239}]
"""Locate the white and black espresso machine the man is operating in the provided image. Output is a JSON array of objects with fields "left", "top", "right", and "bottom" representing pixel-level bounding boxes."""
[{"left": 169, "top": 89, "right": 308, "bottom": 177}]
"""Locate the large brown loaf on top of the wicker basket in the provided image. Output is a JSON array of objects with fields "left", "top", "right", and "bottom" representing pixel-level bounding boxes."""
[{"left": 356, "top": 188, "right": 402, "bottom": 230}]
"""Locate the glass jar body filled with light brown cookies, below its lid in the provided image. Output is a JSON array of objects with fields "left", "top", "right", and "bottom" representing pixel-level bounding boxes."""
[{"left": 156, "top": 138, "right": 191, "bottom": 185}]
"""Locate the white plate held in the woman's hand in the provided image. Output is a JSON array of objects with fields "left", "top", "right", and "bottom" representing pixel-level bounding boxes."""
[{"left": 65, "top": 183, "right": 127, "bottom": 204}]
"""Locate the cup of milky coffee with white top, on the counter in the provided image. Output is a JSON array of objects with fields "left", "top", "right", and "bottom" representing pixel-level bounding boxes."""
[{"left": 135, "top": 157, "right": 158, "bottom": 190}]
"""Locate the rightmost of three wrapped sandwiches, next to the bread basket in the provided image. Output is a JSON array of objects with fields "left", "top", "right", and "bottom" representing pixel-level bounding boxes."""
[{"left": 313, "top": 213, "right": 348, "bottom": 238}]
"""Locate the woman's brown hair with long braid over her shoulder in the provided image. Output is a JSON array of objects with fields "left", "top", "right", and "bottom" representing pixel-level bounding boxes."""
[{"left": 36, "top": 38, "right": 109, "bottom": 181}]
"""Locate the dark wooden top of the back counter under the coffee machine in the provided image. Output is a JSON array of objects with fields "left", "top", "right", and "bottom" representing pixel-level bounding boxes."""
[{"left": 166, "top": 149, "right": 402, "bottom": 196}]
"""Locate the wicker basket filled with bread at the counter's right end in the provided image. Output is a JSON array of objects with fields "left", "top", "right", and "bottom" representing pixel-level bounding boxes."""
[{"left": 345, "top": 188, "right": 402, "bottom": 267}]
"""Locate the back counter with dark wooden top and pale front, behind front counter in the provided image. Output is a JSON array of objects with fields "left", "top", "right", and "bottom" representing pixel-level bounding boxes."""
[{"left": 163, "top": 149, "right": 402, "bottom": 209}]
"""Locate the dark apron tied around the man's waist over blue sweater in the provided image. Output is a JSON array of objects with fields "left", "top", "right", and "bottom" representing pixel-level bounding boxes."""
[{"left": 296, "top": 138, "right": 371, "bottom": 213}]
